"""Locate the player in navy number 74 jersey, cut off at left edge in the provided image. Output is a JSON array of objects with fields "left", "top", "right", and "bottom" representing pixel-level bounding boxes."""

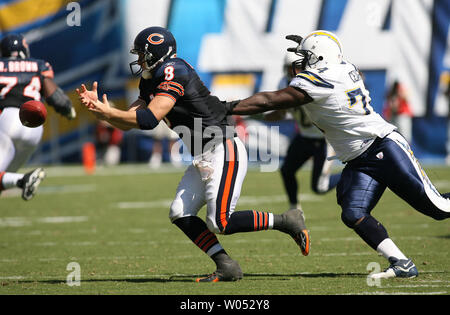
[{"left": 0, "top": 34, "right": 76, "bottom": 200}]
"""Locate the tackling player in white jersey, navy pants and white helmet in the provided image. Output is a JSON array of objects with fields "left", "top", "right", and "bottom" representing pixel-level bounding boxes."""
[{"left": 228, "top": 30, "right": 450, "bottom": 278}]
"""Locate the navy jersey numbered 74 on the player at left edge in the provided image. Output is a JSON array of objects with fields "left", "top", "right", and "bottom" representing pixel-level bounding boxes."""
[{"left": 0, "top": 58, "right": 54, "bottom": 110}]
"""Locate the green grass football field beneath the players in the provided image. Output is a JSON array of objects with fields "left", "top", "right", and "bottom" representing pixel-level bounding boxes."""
[{"left": 0, "top": 165, "right": 450, "bottom": 295}]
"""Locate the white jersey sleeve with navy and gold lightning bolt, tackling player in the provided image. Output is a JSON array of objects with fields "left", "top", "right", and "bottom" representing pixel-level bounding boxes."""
[{"left": 289, "top": 71, "right": 334, "bottom": 100}]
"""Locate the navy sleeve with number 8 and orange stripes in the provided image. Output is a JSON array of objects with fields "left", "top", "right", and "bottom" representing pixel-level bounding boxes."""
[{"left": 155, "top": 61, "right": 189, "bottom": 102}]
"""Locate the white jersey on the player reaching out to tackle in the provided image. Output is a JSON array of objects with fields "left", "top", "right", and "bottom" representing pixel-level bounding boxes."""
[{"left": 290, "top": 62, "right": 397, "bottom": 162}]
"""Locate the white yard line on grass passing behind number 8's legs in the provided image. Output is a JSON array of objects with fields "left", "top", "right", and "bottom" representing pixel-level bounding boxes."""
[{"left": 114, "top": 194, "right": 321, "bottom": 209}]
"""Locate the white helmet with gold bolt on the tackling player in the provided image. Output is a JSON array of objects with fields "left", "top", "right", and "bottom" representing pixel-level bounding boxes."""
[{"left": 289, "top": 30, "right": 344, "bottom": 70}]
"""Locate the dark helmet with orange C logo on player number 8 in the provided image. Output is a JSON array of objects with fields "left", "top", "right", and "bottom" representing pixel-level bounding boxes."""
[{"left": 130, "top": 26, "right": 177, "bottom": 76}]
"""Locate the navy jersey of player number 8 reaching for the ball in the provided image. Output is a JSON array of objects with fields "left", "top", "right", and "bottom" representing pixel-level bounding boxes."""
[{"left": 139, "top": 58, "right": 235, "bottom": 155}]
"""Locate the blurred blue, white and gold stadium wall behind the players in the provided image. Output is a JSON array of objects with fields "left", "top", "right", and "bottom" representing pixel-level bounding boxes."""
[{"left": 0, "top": 0, "right": 450, "bottom": 165}]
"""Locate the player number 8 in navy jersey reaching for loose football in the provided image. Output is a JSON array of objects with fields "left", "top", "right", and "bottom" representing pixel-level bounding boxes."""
[{"left": 77, "top": 27, "right": 309, "bottom": 282}]
